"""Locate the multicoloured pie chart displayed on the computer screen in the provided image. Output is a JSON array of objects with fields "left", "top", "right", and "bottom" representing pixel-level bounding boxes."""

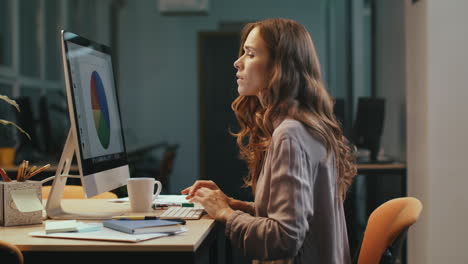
[{"left": 91, "top": 71, "right": 110, "bottom": 149}]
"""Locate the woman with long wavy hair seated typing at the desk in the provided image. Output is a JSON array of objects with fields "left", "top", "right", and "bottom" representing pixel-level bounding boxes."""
[{"left": 182, "top": 19, "right": 356, "bottom": 264}]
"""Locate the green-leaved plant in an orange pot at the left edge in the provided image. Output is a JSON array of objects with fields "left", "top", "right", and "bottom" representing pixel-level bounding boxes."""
[{"left": 0, "top": 95, "right": 31, "bottom": 165}]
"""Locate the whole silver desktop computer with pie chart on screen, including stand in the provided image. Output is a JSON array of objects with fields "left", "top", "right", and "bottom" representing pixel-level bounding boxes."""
[{"left": 46, "top": 31, "right": 130, "bottom": 219}]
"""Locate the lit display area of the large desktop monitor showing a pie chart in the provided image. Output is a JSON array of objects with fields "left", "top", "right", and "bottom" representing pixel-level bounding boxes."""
[{"left": 66, "top": 35, "right": 126, "bottom": 171}]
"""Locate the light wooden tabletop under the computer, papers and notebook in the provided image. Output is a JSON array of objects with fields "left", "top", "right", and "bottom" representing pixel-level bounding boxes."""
[{"left": 0, "top": 199, "right": 215, "bottom": 252}]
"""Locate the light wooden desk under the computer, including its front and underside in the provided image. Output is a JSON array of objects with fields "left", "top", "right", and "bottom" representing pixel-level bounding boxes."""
[{"left": 0, "top": 199, "right": 217, "bottom": 264}]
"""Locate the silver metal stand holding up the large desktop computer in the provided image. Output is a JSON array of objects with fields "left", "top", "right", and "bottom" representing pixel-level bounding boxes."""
[{"left": 46, "top": 128, "right": 122, "bottom": 220}]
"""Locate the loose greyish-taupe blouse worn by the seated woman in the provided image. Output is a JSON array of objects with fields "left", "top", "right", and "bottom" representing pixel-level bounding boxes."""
[{"left": 225, "top": 119, "right": 351, "bottom": 264}]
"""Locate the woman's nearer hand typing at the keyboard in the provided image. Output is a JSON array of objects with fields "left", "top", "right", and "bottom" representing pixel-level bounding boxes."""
[{"left": 190, "top": 187, "right": 234, "bottom": 223}]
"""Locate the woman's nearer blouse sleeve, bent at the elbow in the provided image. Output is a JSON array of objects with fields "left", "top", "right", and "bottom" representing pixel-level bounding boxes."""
[{"left": 225, "top": 138, "right": 313, "bottom": 260}]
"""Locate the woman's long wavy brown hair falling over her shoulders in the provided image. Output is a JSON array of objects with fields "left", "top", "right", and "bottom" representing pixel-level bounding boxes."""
[{"left": 231, "top": 19, "right": 356, "bottom": 200}]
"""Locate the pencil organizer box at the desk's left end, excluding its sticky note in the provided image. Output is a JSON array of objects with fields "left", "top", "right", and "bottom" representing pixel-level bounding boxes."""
[{"left": 0, "top": 181, "right": 42, "bottom": 226}]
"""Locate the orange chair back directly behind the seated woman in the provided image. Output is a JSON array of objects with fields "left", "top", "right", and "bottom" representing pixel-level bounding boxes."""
[{"left": 353, "top": 197, "right": 422, "bottom": 264}]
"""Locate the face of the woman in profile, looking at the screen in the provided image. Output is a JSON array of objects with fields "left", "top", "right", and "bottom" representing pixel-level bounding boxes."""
[{"left": 234, "top": 27, "right": 269, "bottom": 96}]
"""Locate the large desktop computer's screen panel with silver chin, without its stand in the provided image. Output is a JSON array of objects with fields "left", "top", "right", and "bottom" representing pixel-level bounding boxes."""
[{"left": 62, "top": 31, "right": 129, "bottom": 195}]
